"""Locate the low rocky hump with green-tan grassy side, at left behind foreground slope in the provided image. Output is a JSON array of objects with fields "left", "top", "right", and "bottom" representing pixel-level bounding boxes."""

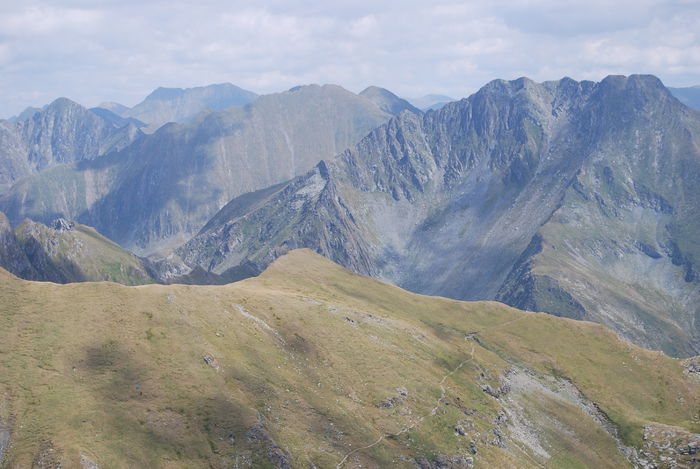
[{"left": 0, "top": 212, "right": 154, "bottom": 285}]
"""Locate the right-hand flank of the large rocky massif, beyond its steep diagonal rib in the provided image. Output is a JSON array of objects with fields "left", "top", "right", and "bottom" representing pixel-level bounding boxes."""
[{"left": 497, "top": 79, "right": 700, "bottom": 355}]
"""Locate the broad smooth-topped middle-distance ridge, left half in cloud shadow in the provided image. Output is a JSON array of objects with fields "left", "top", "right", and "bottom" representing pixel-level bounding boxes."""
[{"left": 0, "top": 85, "right": 400, "bottom": 254}]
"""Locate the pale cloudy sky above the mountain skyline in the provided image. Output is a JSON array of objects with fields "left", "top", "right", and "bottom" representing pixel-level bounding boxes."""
[{"left": 0, "top": 0, "right": 700, "bottom": 117}]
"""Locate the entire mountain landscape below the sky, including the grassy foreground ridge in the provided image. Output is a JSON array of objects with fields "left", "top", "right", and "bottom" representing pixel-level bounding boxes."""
[{"left": 0, "top": 75, "right": 700, "bottom": 469}]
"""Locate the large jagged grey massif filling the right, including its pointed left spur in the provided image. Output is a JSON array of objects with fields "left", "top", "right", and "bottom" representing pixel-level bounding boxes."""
[{"left": 178, "top": 76, "right": 700, "bottom": 355}]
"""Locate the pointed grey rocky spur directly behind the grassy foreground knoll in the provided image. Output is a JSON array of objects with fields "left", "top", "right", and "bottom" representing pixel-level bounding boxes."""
[{"left": 177, "top": 162, "right": 375, "bottom": 275}]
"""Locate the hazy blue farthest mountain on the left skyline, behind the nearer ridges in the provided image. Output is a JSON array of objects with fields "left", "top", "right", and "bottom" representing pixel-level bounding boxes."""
[{"left": 121, "top": 83, "right": 258, "bottom": 130}]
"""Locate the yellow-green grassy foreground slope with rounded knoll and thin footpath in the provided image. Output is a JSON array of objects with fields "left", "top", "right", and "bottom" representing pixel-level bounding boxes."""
[{"left": 0, "top": 250, "right": 700, "bottom": 468}]
